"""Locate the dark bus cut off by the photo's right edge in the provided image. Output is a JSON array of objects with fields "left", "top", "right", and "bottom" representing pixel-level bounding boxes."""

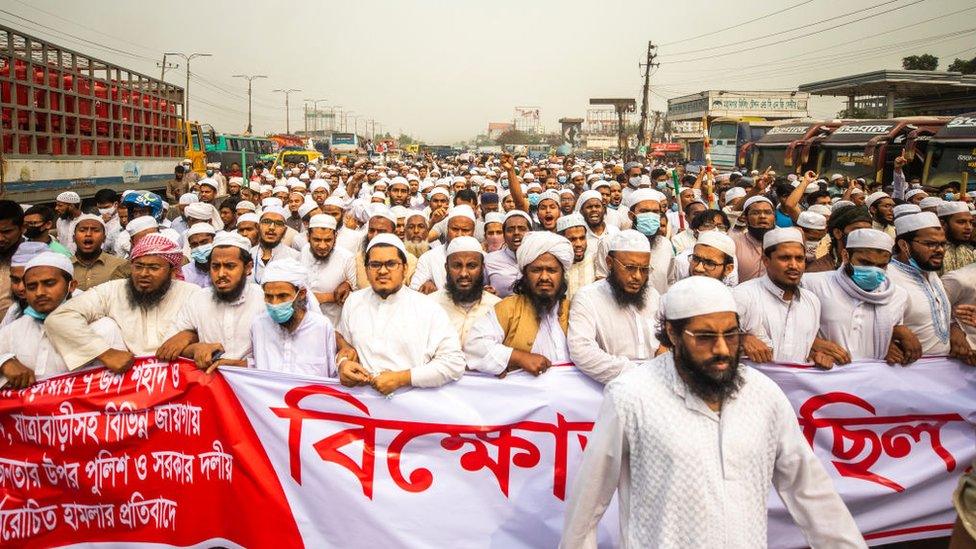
[{"left": 922, "top": 112, "right": 976, "bottom": 191}]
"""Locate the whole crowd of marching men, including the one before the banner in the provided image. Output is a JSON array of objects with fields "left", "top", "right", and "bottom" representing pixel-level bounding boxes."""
[{"left": 0, "top": 149, "right": 976, "bottom": 546}]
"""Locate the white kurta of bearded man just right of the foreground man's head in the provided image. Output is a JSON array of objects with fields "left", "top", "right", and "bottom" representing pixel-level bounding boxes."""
[{"left": 732, "top": 275, "right": 820, "bottom": 363}]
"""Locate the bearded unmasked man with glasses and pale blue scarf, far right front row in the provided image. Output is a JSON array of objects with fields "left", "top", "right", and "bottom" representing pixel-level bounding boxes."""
[{"left": 888, "top": 212, "right": 974, "bottom": 363}]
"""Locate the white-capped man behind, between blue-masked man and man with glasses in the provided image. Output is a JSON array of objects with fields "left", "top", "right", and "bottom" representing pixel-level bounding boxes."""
[{"left": 301, "top": 214, "right": 357, "bottom": 325}]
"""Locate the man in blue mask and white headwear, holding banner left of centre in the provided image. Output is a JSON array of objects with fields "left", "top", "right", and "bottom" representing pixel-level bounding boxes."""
[{"left": 249, "top": 258, "right": 336, "bottom": 377}]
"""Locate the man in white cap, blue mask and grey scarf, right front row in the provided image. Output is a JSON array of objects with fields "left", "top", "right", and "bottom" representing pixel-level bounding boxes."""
[{"left": 803, "top": 229, "right": 922, "bottom": 364}]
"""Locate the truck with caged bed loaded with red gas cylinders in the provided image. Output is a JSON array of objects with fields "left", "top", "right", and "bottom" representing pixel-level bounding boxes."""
[{"left": 0, "top": 25, "right": 206, "bottom": 203}]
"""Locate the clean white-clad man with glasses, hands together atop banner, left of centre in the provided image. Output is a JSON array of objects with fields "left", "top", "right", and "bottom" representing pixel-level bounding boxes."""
[{"left": 336, "top": 233, "right": 464, "bottom": 394}]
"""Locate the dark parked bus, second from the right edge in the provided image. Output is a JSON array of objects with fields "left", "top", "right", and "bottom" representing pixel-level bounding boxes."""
[{"left": 816, "top": 116, "right": 949, "bottom": 184}]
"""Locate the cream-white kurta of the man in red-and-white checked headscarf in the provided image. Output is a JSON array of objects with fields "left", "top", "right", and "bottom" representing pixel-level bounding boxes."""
[{"left": 44, "top": 278, "right": 200, "bottom": 370}]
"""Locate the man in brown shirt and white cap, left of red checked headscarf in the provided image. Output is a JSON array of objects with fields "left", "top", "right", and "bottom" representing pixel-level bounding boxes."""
[{"left": 71, "top": 214, "right": 129, "bottom": 292}]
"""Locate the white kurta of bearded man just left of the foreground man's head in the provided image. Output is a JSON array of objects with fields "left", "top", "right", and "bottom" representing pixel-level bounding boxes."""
[{"left": 567, "top": 279, "right": 661, "bottom": 383}]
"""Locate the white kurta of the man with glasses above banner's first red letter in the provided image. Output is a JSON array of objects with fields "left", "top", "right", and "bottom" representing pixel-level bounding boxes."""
[{"left": 338, "top": 287, "right": 464, "bottom": 387}]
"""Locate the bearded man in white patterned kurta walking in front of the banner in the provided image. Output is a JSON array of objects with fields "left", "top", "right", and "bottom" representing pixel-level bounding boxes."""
[{"left": 560, "top": 276, "right": 865, "bottom": 549}]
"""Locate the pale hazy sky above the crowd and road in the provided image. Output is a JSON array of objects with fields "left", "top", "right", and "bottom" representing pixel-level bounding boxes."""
[{"left": 0, "top": 0, "right": 976, "bottom": 143}]
